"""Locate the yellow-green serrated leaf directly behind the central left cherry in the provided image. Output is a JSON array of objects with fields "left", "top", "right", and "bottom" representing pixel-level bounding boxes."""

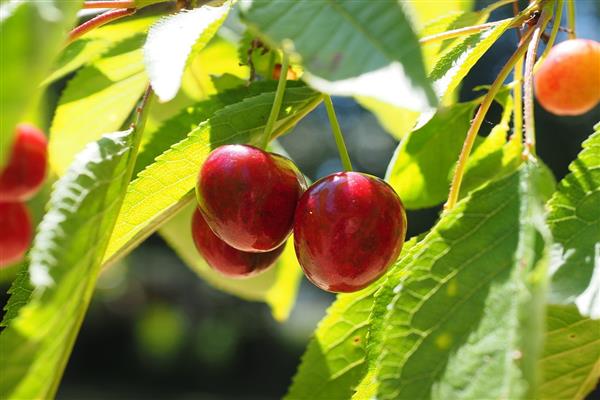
[{"left": 105, "top": 87, "right": 321, "bottom": 263}]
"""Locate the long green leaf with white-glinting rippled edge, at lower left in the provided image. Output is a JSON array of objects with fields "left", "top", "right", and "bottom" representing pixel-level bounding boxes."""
[{"left": 0, "top": 124, "right": 143, "bottom": 399}]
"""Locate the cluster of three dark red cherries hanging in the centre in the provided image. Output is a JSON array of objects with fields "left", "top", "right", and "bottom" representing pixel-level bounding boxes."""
[{"left": 192, "top": 145, "right": 406, "bottom": 292}]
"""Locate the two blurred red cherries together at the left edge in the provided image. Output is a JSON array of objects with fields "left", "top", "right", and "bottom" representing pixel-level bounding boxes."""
[{"left": 0, "top": 124, "right": 48, "bottom": 267}]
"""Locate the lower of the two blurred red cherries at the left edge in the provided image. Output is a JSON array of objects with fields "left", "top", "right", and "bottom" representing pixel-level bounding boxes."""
[{"left": 0, "top": 202, "right": 31, "bottom": 267}]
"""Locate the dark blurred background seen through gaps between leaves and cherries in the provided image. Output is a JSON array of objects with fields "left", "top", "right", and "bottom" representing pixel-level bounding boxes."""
[{"left": 0, "top": 0, "right": 600, "bottom": 400}]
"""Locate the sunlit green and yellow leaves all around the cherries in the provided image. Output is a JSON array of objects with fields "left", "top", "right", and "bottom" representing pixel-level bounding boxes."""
[{"left": 0, "top": 0, "right": 600, "bottom": 400}]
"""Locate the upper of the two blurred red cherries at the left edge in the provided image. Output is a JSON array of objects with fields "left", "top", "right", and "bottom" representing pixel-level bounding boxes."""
[{"left": 0, "top": 124, "right": 48, "bottom": 201}]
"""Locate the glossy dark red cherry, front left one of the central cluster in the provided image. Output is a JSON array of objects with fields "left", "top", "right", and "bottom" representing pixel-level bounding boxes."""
[{"left": 196, "top": 145, "right": 306, "bottom": 252}]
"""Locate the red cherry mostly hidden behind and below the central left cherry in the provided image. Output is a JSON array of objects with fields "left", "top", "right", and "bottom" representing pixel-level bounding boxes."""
[{"left": 192, "top": 209, "right": 285, "bottom": 278}]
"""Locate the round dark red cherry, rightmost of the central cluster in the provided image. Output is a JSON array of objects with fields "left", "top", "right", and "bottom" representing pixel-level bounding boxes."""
[{"left": 294, "top": 172, "right": 406, "bottom": 292}]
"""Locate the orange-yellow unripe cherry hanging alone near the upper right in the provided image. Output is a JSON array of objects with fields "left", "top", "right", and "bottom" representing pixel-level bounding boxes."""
[{"left": 534, "top": 39, "right": 600, "bottom": 115}]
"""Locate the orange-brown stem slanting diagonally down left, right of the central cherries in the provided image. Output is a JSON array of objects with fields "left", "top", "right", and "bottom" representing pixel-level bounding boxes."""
[{"left": 444, "top": 24, "right": 533, "bottom": 211}]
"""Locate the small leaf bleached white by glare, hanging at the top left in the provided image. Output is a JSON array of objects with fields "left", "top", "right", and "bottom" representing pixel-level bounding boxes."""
[{"left": 144, "top": 2, "right": 231, "bottom": 102}]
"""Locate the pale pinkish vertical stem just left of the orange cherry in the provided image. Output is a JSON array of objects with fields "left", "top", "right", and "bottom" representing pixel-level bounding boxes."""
[{"left": 523, "top": 10, "right": 550, "bottom": 156}]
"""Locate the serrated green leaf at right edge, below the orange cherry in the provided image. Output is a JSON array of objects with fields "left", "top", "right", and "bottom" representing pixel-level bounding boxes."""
[{"left": 548, "top": 123, "right": 600, "bottom": 319}]
